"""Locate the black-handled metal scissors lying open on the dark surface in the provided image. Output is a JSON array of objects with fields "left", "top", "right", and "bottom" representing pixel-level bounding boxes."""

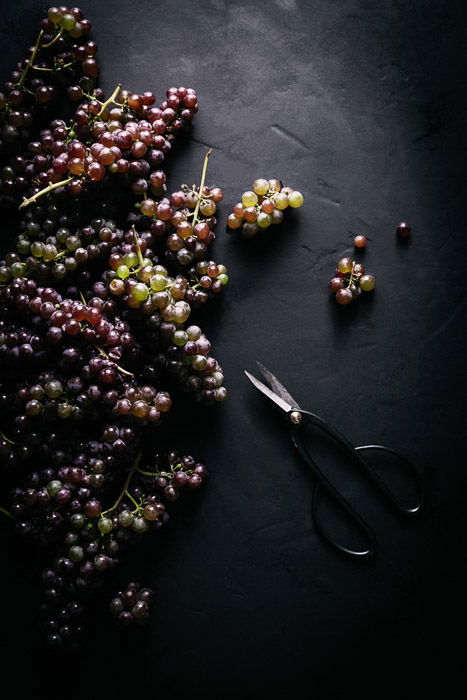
[{"left": 245, "top": 362, "right": 423, "bottom": 558}]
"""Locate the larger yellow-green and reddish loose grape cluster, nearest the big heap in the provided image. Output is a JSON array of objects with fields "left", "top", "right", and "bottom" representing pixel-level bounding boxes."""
[{"left": 227, "top": 178, "right": 303, "bottom": 238}]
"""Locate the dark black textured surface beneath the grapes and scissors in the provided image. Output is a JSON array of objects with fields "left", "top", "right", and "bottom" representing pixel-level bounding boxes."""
[{"left": 0, "top": 0, "right": 467, "bottom": 700}]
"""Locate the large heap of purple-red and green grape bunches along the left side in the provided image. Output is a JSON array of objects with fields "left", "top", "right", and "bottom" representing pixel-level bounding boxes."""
[{"left": 0, "top": 7, "right": 227, "bottom": 648}]
